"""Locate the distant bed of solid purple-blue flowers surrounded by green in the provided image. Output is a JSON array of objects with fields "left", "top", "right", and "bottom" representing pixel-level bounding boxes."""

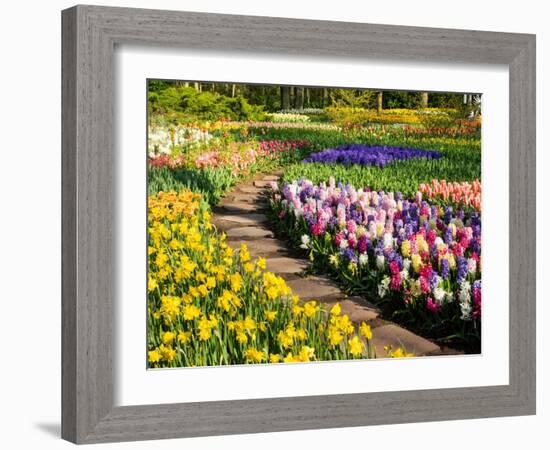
[{"left": 303, "top": 144, "right": 441, "bottom": 167}]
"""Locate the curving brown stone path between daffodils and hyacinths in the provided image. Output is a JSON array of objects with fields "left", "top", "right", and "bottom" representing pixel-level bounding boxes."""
[{"left": 212, "top": 172, "right": 456, "bottom": 357}]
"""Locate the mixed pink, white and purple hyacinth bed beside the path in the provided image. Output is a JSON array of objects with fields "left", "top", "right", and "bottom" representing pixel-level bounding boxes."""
[{"left": 271, "top": 179, "right": 481, "bottom": 352}]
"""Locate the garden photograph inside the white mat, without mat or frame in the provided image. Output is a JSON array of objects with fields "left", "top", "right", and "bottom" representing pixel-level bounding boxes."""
[{"left": 146, "top": 79, "right": 482, "bottom": 369}]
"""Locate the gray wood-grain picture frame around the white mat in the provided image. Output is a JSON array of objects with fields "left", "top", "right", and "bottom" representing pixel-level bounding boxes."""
[{"left": 62, "top": 6, "right": 536, "bottom": 443}]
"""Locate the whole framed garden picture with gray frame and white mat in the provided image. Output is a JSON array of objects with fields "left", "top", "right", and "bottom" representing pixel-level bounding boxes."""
[{"left": 62, "top": 6, "right": 535, "bottom": 443}]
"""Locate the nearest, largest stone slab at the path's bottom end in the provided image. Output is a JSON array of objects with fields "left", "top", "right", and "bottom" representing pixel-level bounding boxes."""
[{"left": 372, "top": 324, "right": 439, "bottom": 358}]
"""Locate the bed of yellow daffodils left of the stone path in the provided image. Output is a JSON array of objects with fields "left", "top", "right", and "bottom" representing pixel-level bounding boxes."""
[{"left": 147, "top": 190, "right": 378, "bottom": 368}]
